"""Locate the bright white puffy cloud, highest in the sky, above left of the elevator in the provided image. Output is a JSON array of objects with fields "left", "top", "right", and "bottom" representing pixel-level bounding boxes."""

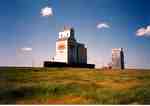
[{"left": 41, "top": 6, "right": 53, "bottom": 17}]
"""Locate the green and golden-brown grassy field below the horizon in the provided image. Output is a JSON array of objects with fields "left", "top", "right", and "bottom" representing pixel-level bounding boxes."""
[{"left": 0, "top": 68, "right": 150, "bottom": 104}]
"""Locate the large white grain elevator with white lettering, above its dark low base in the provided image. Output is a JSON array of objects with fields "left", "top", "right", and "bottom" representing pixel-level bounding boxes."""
[{"left": 54, "top": 28, "right": 87, "bottom": 64}]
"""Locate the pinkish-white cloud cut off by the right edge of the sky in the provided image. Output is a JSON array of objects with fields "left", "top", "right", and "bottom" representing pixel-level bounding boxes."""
[{"left": 136, "top": 25, "right": 150, "bottom": 36}]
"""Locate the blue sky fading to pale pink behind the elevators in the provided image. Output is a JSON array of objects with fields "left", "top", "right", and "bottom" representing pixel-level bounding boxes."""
[{"left": 0, "top": 0, "right": 150, "bottom": 68}]
